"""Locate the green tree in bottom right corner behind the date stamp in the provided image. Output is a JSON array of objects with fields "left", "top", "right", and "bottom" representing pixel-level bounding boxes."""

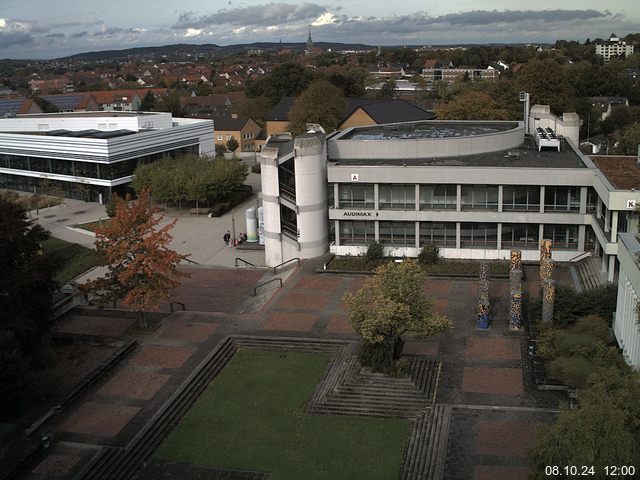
[{"left": 529, "top": 368, "right": 640, "bottom": 480}]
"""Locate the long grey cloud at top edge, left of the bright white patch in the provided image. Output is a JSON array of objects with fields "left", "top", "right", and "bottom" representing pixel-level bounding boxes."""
[{"left": 173, "top": 3, "right": 325, "bottom": 29}]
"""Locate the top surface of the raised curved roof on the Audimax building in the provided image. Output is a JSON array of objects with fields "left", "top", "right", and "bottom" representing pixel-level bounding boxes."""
[{"left": 337, "top": 120, "right": 518, "bottom": 141}]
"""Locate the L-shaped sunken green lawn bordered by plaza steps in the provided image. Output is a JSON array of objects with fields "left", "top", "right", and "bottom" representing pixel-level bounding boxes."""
[{"left": 155, "top": 350, "right": 410, "bottom": 480}]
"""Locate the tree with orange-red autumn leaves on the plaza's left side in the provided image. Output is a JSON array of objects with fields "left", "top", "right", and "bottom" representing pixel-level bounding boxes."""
[{"left": 84, "top": 188, "right": 186, "bottom": 328}]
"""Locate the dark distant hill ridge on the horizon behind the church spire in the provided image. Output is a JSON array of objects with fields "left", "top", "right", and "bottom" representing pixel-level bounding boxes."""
[{"left": 64, "top": 42, "right": 375, "bottom": 61}]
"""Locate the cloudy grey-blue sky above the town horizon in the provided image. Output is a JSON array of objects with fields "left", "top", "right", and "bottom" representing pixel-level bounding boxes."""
[{"left": 0, "top": 0, "right": 640, "bottom": 59}]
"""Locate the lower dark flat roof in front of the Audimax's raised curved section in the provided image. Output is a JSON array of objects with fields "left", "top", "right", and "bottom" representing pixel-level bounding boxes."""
[{"left": 329, "top": 137, "right": 587, "bottom": 168}]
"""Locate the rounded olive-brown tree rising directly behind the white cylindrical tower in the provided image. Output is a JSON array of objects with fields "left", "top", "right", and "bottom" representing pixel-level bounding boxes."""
[{"left": 289, "top": 80, "right": 346, "bottom": 135}]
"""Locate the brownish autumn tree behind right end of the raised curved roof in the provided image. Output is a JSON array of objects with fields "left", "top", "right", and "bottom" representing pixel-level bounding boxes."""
[{"left": 436, "top": 91, "right": 510, "bottom": 120}]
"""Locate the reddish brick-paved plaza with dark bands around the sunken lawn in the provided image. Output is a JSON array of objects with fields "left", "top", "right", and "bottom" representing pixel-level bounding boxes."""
[{"left": 22, "top": 261, "right": 568, "bottom": 480}]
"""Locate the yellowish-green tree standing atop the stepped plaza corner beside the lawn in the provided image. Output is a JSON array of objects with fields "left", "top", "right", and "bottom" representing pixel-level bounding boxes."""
[{"left": 343, "top": 260, "right": 452, "bottom": 371}]
